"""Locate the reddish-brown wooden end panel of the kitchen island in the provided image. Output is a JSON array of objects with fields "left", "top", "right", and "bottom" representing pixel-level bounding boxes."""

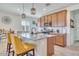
[{"left": 47, "top": 37, "right": 55, "bottom": 56}]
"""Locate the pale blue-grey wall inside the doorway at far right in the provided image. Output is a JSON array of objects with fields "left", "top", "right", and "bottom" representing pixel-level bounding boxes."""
[{"left": 72, "top": 9, "right": 79, "bottom": 40}]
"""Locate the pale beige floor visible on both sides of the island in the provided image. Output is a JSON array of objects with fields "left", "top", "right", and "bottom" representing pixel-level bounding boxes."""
[{"left": 0, "top": 35, "right": 79, "bottom": 56}]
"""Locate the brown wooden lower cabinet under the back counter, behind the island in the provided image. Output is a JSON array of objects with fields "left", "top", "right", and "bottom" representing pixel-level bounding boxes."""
[{"left": 55, "top": 35, "right": 66, "bottom": 47}]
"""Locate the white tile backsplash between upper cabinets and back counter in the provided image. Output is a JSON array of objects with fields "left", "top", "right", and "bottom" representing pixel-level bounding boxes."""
[{"left": 37, "top": 27, "right": 67, "bottom": 33}]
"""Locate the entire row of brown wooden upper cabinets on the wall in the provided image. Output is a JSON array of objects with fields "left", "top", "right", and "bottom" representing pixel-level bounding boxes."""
[{"left": 38, "top": 10, "right": 67, "bottom": 27}]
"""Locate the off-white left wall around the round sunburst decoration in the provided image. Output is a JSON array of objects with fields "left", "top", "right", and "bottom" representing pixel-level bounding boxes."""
[{"left": 0, "top": 11, "right": 22, "bottom": 31}]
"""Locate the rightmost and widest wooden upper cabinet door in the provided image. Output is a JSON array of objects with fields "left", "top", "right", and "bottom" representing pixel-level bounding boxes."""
[{"left": 57, "top": 11, "right": 66, "bottom": 27}]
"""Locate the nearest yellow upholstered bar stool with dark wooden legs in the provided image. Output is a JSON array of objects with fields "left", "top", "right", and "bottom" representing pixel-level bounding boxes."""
[{"left": 11, "top": 34, "right": 36, "bottom": 56}]
